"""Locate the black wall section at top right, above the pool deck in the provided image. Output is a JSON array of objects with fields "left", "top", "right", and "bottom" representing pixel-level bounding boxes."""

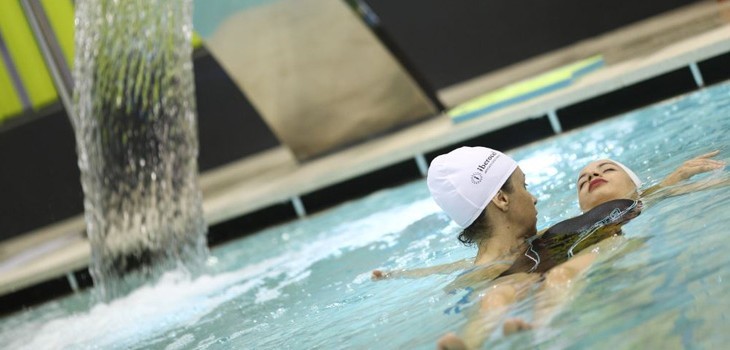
[{"left": 365, "top": 0, "right": 698, "bottom": 90}]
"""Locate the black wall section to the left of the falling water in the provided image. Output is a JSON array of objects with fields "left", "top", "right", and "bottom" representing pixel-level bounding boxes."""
[{"left": 0, "top": 106, "right": 83, "bottom": 239}]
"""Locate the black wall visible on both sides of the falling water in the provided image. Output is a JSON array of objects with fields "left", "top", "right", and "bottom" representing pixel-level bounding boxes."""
[{"left": 0, "top": 50, "right": 279, "bottom": 240}]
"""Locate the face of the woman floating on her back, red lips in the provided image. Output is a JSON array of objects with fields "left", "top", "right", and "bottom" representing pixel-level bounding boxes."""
[{"left": 577, "top": 159, "right": 638, "bottom": 212}]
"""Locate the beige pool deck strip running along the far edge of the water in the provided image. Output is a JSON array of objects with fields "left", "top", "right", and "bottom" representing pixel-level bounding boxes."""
[{"left": 0, "top": 2, "right": 730, "bottom": 296}]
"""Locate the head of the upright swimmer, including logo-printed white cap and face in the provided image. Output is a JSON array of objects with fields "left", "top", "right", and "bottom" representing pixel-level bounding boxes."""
[{"left": 427, "top": 147, "right": 537, "bottom": 243}]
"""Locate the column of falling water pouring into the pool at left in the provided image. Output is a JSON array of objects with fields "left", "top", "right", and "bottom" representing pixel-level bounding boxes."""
[{"left": 71, "top": 0, "right": 207, "bottom": 300}]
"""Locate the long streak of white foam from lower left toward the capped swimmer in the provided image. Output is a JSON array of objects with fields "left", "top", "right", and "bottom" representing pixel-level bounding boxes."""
[{"left": 0, "top": 199, "right": 439, "bottom": 349}]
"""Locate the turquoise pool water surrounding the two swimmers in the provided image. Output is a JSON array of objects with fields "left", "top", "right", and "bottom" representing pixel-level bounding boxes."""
[{"left": 0, "top": 80, "right": 730, "bottom": 349}]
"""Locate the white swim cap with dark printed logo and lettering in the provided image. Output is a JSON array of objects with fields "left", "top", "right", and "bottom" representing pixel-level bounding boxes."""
[{"left": 426, "top": 147, "right": 517, "bottom": 227}]
